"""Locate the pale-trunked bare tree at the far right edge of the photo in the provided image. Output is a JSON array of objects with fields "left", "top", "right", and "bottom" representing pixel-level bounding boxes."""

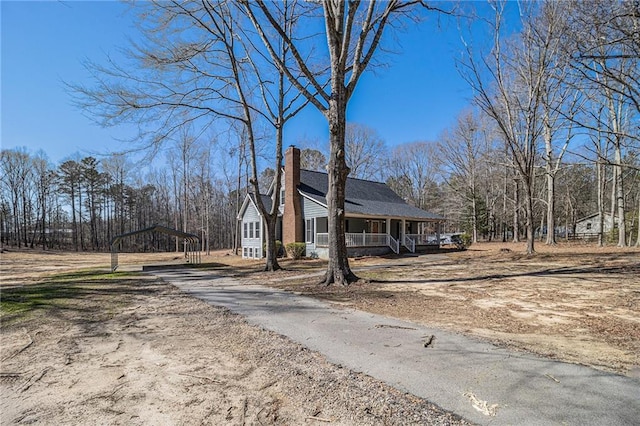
[{"left": 564, "top": 0, "right": 640, "bottom": 247}]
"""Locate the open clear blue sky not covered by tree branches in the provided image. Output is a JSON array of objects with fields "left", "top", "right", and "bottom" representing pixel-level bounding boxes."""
[{"left": 0, "top": 1, "right": 480, "bottom": 163}]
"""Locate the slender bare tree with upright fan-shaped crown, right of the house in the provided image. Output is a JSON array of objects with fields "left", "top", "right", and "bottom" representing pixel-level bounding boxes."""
[{"left": 460, "top": 2, "right": 558, "bottom": 254}]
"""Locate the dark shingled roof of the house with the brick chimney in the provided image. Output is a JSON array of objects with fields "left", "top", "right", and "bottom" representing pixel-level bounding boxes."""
[{"left": 298, "top": 170, "right": 444, "bottom": 220}]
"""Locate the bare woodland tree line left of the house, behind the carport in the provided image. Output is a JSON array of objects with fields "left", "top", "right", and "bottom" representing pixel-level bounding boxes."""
[{"left": 0, "top": 148, "right": 237, "bottom": 251}]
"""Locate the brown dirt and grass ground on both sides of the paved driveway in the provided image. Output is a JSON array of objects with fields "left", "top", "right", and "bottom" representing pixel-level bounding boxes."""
[{"left": 0, "top": 243, "right": 640, "bottom": 425}]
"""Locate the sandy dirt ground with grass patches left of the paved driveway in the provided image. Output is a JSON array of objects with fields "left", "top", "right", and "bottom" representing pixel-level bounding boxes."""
[{"left": 0, "top": 252, "right": 468, "bottom": 425}]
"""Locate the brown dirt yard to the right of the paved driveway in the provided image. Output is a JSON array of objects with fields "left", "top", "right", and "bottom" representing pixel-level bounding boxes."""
[{"left": 263, "top": 243, "right": 640, "bottom": 377}]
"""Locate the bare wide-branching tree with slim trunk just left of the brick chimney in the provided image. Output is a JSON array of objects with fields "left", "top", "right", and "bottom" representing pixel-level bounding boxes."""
[{"left": 71, "top": 1, "right": 306, "bottom": 270}]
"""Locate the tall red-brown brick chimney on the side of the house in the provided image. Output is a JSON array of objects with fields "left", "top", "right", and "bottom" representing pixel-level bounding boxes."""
[{"left": 282, "top": 145, "right": 304, "bottom": 246}]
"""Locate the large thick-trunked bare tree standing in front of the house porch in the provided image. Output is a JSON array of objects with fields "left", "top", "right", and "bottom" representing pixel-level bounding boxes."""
[{"left": 242, "top": 0, "right": 450, "bottom": 285}]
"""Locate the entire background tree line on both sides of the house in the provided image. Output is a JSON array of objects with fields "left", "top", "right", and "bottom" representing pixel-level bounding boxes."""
[{"left": 0, "top": 110, "right": 640, "bottom": 251}]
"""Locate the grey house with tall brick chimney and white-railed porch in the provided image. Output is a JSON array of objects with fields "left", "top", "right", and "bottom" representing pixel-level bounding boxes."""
[{"left": 237, "top": 146, "right": 444, "bottom": 259}]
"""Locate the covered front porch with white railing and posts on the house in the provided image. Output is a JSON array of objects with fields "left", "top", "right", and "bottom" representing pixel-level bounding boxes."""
[{"left": 315, "top": 217, "right": 442, "bottom": 254}]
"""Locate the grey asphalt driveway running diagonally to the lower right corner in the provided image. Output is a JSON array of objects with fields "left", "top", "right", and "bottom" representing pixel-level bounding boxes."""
[{"left": 154, "top": 269, "right": 640, "bottom": 426}]
